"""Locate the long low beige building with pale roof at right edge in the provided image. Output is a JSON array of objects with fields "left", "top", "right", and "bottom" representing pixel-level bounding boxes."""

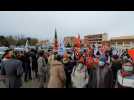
[{"left": 110, "top": 35, "right": 134, "bottom": 49}]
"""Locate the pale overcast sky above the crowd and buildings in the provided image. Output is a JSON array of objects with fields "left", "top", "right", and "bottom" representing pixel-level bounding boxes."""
[{"left": 0, "top": 11, "right": 134, "bottom": 39}]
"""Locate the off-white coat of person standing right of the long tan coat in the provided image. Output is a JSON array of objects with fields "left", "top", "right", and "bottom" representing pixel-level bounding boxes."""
[{"left": 71, "top": 63, "right": 89, "bottom": 88}]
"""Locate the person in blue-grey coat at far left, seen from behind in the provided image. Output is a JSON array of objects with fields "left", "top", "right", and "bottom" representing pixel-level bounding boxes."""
[{"left": 1, "top": 50, "right": 23, "bottom": 88}]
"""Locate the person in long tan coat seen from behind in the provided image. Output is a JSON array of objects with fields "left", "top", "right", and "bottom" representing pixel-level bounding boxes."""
[{"left": 47, "top": 56, "right": 66, "bottom": 88}]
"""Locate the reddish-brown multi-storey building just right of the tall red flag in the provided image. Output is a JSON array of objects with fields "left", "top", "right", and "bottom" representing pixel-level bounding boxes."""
[{"left": 84, "top": 33, "right": 108, "bottom": 46}]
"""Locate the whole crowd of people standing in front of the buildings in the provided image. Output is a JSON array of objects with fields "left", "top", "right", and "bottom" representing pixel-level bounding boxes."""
[{"left": 0, "top": 47, "right": 134, "bottom": 88}]
